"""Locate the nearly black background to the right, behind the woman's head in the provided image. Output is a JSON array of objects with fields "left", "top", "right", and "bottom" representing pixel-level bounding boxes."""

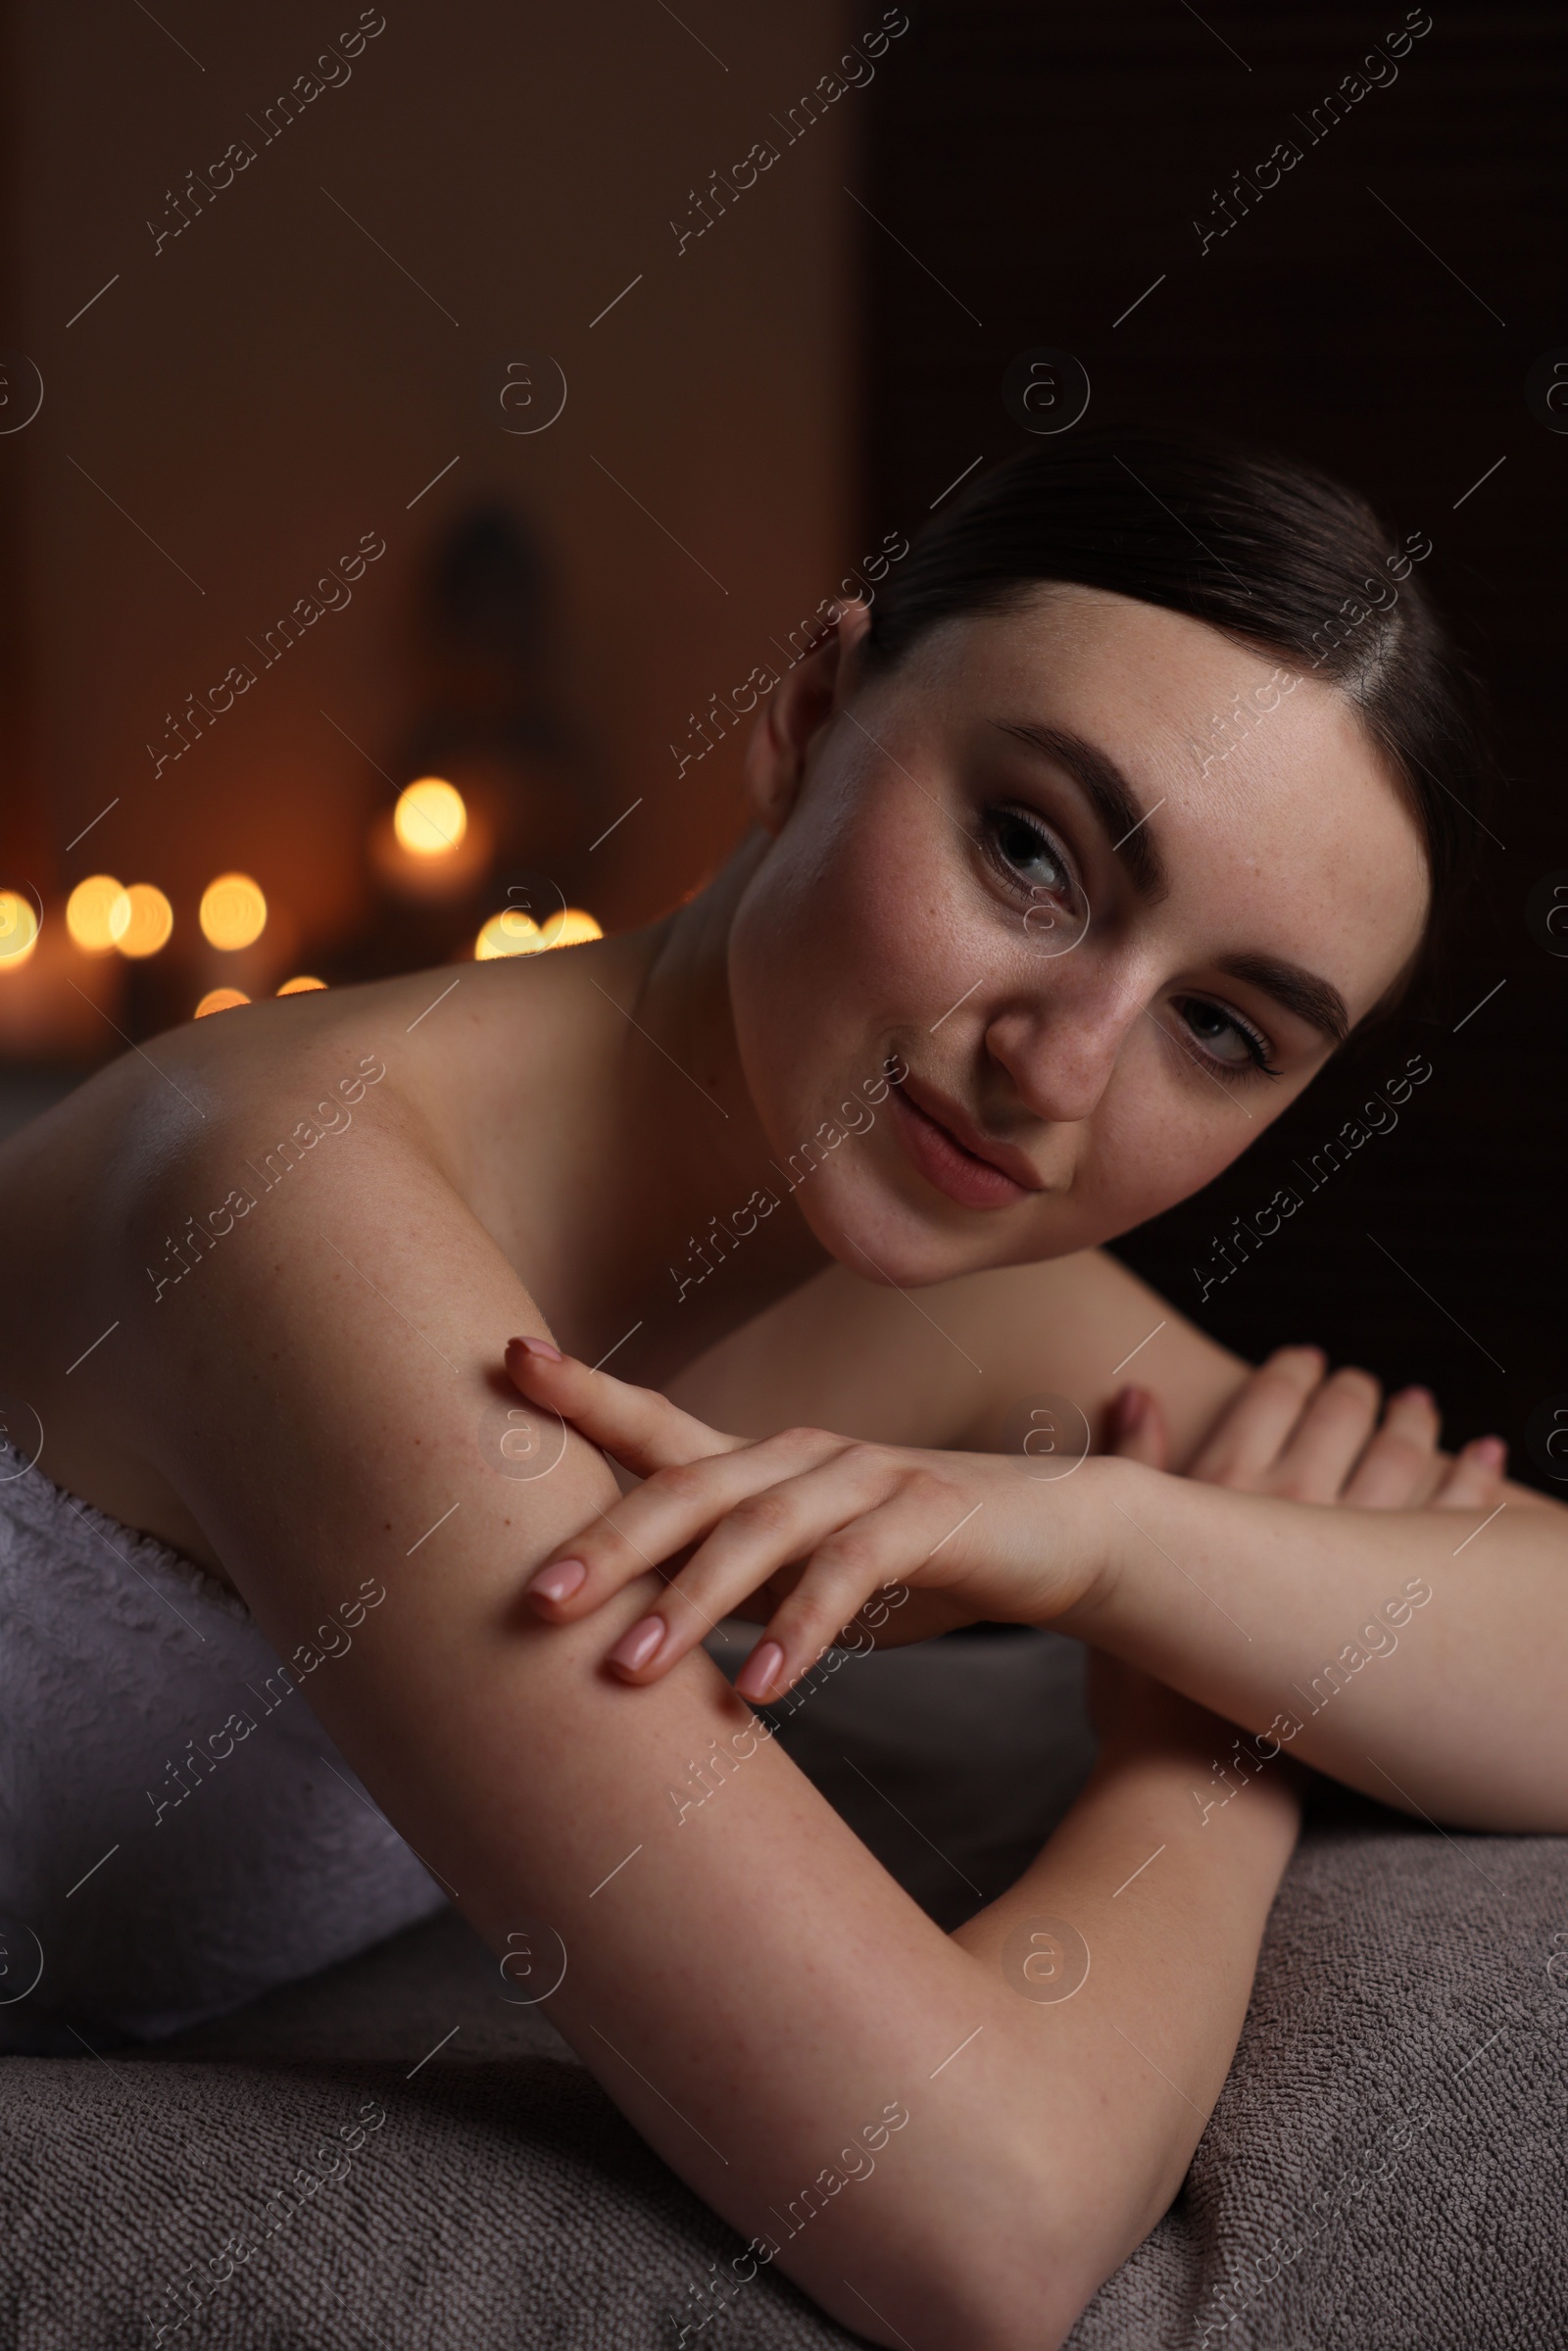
[{"left": 860, "top": 0, "right": 1568, "bottom": 1484}]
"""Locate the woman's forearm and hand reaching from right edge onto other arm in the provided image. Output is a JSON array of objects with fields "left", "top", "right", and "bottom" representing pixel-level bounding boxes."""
[{"left": 514, "top": 1356, "right": 1568, "bottom": 1829}]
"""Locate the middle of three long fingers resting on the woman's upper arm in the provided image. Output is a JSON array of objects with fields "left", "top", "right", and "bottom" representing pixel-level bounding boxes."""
[{"left": 607, "top": 1445, "right": 921, "bottom": 1697}]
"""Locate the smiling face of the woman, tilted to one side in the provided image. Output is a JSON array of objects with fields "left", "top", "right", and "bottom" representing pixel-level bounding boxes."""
[{"left": 731, "top": 588, "right": 1427, "bottom": 1284}]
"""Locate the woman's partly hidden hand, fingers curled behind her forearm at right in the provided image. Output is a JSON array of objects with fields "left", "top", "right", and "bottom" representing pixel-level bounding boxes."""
[{"left": 1109, "top": 1347, "right": 1507, "bottom": 1509}]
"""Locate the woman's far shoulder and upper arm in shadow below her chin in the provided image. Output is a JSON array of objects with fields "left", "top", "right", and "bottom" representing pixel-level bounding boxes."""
[{"left": 672, "top": 1249, "right": 1246, "bottom": 1450}]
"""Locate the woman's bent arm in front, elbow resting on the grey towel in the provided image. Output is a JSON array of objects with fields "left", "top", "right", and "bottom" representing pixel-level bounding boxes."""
[{"left": 113, "top": 1114, "right": 1293, "bottom": 2351}]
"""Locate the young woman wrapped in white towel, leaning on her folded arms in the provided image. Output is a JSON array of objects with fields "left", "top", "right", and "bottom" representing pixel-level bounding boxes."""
[{"left": 0, "top": 440, "right": 1568, "bottom": 2351}]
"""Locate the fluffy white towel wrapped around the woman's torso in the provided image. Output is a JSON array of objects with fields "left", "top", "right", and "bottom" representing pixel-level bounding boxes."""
[{"left": 0, "top": 1442, "right": 444, "bottom": 2050}]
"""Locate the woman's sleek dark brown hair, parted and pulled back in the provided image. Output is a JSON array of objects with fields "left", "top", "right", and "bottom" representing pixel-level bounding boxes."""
[{"left": 865, "top": 430, "right": 1493, "bottom": 1018}]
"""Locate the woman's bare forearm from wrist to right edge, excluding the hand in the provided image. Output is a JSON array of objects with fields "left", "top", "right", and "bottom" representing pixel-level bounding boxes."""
[{"left": 1072, "top": 1462, "right": 1568, "bottom": 1832}]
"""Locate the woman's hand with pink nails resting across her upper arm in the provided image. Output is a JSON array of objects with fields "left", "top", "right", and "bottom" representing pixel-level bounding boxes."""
[{"left": 506, "top": 1340, "right": 1102, "bottom": 1702}]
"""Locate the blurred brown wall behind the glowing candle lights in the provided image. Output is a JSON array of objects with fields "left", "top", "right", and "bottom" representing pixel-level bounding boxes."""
[{"left": 0, "top": 0, "right": 859, "bottom": 1024}]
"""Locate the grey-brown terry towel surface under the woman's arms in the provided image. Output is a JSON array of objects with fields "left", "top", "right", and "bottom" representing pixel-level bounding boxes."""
[{"left": 0, "top": 1634, "right": 1568, "bottom": 2351}]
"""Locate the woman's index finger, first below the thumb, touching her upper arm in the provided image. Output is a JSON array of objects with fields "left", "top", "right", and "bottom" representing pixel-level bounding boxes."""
[{"left": 524, "top": 1430, "right": 844, "bottom": 1625}]
